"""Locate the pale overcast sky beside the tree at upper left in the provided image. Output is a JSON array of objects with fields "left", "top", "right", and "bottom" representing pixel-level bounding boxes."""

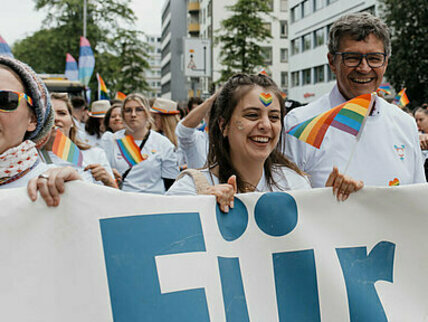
[{"left": 0, "top": 0, "right": 164, "bottom": 46}]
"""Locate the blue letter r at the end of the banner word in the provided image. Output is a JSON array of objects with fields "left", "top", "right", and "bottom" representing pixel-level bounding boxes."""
[{"left": 336, "top": 241, "right": 395, "bottom": 322}]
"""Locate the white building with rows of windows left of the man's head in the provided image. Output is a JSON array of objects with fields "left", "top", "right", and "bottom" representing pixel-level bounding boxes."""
[{"left": 288, "top": 0, "right": 378, "bottom": 103}]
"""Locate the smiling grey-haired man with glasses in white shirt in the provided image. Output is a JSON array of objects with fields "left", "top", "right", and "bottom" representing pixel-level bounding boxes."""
[{"left": 285, "top": 12, "right": 425, "bottom": 187}]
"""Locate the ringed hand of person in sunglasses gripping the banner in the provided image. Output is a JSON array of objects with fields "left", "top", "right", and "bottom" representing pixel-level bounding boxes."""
[{"left": 27, "top": 167, "right": 81, "bottom": 207}]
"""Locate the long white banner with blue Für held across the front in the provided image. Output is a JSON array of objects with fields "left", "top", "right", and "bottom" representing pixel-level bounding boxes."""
[{"left": 0, "top": 182, "right": 428, "bottom": 322}]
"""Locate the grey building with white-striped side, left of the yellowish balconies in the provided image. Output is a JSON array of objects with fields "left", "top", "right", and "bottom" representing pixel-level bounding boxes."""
[{"left": 161, "top": 0, "right": 187, "bottom": 102}]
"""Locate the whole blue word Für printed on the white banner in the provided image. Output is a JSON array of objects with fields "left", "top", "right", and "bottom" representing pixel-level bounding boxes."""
[{"left": 100, "top": 192, "right": 395, "bottom": 322}]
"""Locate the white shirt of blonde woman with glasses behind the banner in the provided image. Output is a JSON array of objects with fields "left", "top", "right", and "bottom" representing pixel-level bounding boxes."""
[{"left": 102, "top": 130, "right": 179, "bottom": 194}]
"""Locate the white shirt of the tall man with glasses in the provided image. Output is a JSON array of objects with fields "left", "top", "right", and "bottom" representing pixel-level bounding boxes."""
[{"left": 284, "top": 86, "right": 425, "bottom": 188}]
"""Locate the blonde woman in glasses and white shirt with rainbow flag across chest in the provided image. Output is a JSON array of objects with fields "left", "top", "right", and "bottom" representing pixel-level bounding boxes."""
[{"left": 102, "top": 93, "right": 178, "bottom": 194}]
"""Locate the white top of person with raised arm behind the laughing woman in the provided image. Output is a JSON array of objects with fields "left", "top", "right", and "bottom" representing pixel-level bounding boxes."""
[{"left": 175, "top": 121, "right": 209, "bottom": 169}]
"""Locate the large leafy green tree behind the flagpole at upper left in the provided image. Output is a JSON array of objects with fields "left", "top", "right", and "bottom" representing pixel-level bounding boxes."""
[{"left": 12, "top": 0, "right": 149, "bottom": 95}]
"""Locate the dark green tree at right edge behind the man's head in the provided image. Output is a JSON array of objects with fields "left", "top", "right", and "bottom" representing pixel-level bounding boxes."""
[{"left": 381, "top": 0, "right": 428, "bottom": 107}]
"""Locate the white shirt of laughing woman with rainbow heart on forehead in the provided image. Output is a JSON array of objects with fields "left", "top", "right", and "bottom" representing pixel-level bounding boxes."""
[{"left": 166, "top": 167, "right": 311, "bottom": 196}]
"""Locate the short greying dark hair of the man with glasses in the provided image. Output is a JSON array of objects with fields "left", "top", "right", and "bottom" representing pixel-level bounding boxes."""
[{"left": 328, "top": 12, "right": 391, "bottom": 56}]
